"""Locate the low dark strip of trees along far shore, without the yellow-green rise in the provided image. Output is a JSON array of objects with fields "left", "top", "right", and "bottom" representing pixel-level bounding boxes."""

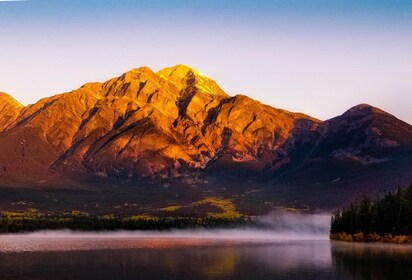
[{"left": 0, "top": 211, "right": 252, "bottom": 233}]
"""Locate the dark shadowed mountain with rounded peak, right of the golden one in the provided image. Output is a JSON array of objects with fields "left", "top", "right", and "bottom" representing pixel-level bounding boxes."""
[{"left": 260, "top": 104, "right": 412, "bottom": 209}]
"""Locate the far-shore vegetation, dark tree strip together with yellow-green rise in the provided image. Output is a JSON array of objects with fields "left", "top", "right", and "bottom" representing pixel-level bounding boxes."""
[{"left": 0, "top": 197, "right": 253, "bottom": 233}]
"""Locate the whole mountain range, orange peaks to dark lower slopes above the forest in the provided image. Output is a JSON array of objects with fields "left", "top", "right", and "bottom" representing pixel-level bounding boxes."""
[{"left": 0, "top": 65, "right": 412, "bottom": 214}]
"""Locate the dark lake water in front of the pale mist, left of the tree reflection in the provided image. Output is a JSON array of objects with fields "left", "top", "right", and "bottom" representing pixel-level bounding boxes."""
[{"left": 0, "top": 244, "right": 330, "bottom": 280}]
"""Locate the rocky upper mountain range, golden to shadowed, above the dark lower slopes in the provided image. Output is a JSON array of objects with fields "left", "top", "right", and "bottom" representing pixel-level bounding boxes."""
[{"left": 0, "top": 65, "right": 412, "bottom": 188}]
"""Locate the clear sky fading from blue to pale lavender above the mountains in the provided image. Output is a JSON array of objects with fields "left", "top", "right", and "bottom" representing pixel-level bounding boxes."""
[{"left": 0, "top": 0, "right": 412, "bottom": 123}]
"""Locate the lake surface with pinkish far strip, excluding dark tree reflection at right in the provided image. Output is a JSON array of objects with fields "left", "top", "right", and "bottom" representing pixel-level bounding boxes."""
[{"left": 0, "top": 235, "right": 332, "bottom": 280}]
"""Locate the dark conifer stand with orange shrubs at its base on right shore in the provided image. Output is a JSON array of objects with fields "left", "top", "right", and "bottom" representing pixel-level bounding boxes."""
[{"left": 330, "top": 184, "right": 412, "bottom": 243}]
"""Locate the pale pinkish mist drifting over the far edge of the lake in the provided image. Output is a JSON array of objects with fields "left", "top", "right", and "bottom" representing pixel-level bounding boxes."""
[{"left": 0, "top": 211, "right": 330, "bottom": 253}]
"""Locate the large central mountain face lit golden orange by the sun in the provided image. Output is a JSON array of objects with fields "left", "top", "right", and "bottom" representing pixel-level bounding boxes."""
[{"left": 1, "top": 65, "right": 318, "bottom": 182}]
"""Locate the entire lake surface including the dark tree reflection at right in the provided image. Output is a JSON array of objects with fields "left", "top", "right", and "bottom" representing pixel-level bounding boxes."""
[{"left": 0, "top": 232, "right": 412, "bottom": 280}]
